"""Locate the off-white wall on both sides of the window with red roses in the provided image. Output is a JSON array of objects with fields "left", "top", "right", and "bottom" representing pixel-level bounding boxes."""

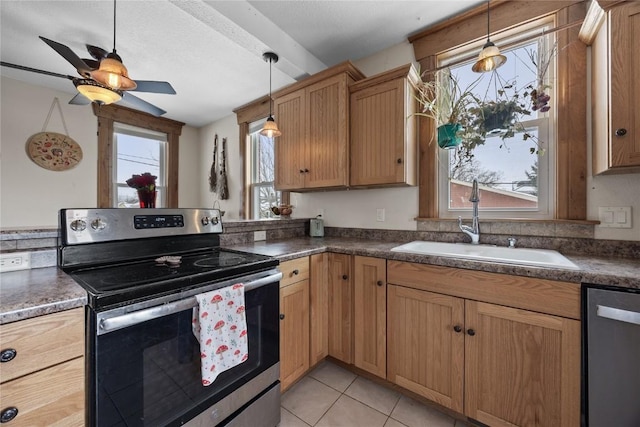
[{"left": 0, "top": 77, "right": 200, "bottom": 229}]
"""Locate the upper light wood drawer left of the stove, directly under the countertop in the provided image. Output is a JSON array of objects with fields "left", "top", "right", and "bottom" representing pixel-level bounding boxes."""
[{"left": 0, "top": 308, "right": 84, "bottom": 387}]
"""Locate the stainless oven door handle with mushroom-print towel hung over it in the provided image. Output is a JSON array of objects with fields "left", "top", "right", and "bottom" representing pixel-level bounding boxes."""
[{"left": 98, "top": 272, "right": 282, "bottom": 335}]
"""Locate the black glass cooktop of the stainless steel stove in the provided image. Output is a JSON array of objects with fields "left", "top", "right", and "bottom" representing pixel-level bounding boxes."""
[{"left": 69, "top": 248, "right": 278, "bottom": 308}]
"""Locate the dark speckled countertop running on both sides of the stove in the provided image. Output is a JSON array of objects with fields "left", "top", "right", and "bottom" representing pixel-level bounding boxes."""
[{"left": 0, "top": 237, "right": 640, "bottom": 324}]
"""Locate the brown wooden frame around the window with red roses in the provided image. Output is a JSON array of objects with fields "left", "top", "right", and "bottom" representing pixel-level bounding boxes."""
[{"left": 92, "top": 103, "right": 184, "bottom": 208}]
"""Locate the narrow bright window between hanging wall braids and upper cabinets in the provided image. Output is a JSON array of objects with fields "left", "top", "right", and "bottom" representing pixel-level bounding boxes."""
[{"left": 249, "top": 120, "right": 281, "bottom": 219}]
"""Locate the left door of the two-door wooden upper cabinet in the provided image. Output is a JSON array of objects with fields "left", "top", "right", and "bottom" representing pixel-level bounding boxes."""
[{"left": 274, "top": 89, "right": 308, "bottom": 190}]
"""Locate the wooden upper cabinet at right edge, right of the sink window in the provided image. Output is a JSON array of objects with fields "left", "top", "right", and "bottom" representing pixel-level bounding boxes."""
[{"left": 587, "top": 2, "right": 640, "bottom": 174}]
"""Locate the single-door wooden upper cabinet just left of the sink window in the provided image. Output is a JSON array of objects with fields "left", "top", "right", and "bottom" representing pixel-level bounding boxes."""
[{"left": 350, "top": 64, "right": 419, "bottom": 187}]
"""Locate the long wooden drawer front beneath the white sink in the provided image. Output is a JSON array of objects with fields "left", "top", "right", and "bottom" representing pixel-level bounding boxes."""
[{"left": 387, "top": 261, "right": 580, "bottom": 319}]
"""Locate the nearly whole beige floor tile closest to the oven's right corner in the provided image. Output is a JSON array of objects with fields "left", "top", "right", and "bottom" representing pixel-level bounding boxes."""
[{"left": 282, "top": 377, "right": 340, "bottom": 425}]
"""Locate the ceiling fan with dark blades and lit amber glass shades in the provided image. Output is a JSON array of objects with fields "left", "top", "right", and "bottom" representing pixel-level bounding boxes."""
[{"left": 0, "top": 0, "right": 176, "bottom": 116}]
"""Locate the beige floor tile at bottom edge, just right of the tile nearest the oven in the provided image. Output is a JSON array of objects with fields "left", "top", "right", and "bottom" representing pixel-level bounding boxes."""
[{"left": 316, "top": 395, "right": 387, "bottom": 427}]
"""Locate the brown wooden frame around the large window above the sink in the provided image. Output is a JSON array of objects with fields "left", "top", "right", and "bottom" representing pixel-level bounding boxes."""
[{"left": 409, "top": 0, "right": 587, "bottom": 220}]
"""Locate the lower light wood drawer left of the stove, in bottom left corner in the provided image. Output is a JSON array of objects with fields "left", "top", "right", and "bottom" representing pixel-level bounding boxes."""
[{"left": 0, "top": 358, "right": 85, "bottom": 427}]
